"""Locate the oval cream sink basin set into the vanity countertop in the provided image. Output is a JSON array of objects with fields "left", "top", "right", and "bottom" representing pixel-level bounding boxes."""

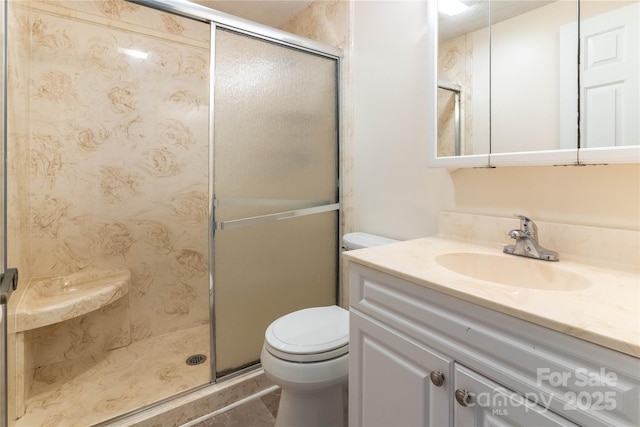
[{"left": 436, "top": 252, "right": 591, "bottom": 291}]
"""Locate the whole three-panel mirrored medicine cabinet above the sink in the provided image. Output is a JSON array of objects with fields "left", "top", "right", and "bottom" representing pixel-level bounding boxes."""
[{"left": 433, "top": 0, "right": 640, "bottom": 166}]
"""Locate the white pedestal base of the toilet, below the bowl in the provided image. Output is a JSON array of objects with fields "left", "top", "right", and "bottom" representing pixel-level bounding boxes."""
[{"left": 276, "top": 384, "right": 346, "bottom": 427}]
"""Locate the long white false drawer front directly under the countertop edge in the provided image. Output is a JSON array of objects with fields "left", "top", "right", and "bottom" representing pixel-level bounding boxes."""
[{"left": 349, "top": 262, "right": 640, "bottom": 426}]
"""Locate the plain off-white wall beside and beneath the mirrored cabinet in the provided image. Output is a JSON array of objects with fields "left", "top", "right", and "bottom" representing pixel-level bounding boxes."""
[{"left": 347, "top": 0, "right": 640, "bottom": 239}]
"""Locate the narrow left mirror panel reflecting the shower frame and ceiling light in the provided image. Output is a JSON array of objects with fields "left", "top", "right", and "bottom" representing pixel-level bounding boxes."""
[{"left": 437, "top": 0, "right": 489, "bottom": 157}]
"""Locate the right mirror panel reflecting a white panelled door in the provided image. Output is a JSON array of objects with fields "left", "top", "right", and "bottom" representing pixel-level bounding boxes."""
[{"left": 580, "top": 0, "right": 640, "bottom": 148}]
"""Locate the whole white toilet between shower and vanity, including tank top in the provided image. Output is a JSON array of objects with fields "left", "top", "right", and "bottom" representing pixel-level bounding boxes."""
[{"left": 260, "top": 233, "right": 397, "bottom": 427}]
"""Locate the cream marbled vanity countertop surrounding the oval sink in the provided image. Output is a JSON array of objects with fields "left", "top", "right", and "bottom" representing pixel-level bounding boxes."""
[{"left": 343, "top": 237, "right": 640, "bottom": 357}]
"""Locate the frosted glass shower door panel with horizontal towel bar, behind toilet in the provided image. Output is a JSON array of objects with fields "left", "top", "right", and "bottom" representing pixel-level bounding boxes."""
[{"left": 213, "top": 28, "right": 339, "bottom": 377}]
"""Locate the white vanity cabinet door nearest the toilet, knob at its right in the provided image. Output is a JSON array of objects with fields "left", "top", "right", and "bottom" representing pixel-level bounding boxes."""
[{"left": 349, "top": 311, "right": 451, "bottom": 427}]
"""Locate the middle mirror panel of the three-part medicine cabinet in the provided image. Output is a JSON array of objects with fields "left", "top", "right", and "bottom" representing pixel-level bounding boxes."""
[{"left": 491, "top": 0, "right": 578, "bottom": 153}]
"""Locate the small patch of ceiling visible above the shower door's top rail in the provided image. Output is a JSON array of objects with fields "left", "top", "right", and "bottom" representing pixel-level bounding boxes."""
[{"left": 190, "top": 0, "right": 313, "bottom": 28}]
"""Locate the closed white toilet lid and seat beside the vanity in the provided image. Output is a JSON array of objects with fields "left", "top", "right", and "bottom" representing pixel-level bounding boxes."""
[{"left": 265, "top": 305, "right": 349, "bottom": 362}]
